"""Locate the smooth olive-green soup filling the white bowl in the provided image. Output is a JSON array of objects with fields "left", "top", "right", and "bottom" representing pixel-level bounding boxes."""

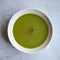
[{"left": 13, "top": 14, "right": 48, "bottom": 48}]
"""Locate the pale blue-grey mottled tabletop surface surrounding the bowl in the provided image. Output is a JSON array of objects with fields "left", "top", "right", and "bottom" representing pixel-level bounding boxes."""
[{"left": 0, "top": 0, "right": 60, "bottom": 60}]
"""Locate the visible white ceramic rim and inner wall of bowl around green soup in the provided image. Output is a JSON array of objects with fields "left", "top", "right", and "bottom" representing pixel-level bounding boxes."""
[{"left": 7, "top": 9, "right": 52, "bottom": 53}]
